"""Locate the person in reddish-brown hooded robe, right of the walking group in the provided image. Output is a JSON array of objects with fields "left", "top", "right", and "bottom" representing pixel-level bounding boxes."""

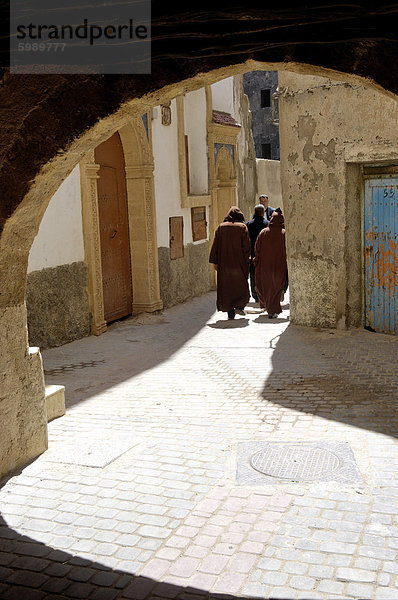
[{"left": 253, "top": 209, "right": 287, "bottom": 319}]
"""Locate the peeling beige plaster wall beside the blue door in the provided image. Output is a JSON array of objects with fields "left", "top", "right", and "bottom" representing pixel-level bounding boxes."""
[{"left": 279, "top": 72, "right": 398, "bottom": 327}]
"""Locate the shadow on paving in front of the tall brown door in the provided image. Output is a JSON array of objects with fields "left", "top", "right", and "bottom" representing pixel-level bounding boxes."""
[{"left": 42, "top": 293, "right": 218, "bottom": 406}]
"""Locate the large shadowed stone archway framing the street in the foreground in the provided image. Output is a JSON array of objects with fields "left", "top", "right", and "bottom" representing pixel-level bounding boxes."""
[{"left": 0, "top": 2, "right": 397, "bottom": 476}]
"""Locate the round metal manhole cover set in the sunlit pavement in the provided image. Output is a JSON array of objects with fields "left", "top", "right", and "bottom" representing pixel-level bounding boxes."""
[{"left": 250, "top": 445, "right": 342, "bottom": 481}]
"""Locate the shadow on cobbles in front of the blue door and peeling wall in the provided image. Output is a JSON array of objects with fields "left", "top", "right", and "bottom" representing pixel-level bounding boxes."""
[{"left": 262, "top": 325, "right": 398, "bottom": 437}]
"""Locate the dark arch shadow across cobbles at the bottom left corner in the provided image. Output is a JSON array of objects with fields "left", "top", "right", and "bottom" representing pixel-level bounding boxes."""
[{"left": 0, "top": 512, "right": 305, "bottom": 600}]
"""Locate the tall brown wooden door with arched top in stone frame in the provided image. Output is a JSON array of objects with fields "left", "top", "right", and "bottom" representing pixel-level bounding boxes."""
[{"left": 95, "top": 132, "right": 133, "bottom": 323}]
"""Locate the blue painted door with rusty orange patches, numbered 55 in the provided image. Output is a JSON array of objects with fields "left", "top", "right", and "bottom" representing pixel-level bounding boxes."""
[{"left": 364, "top": 176, "right": 398, "bottom": 335}]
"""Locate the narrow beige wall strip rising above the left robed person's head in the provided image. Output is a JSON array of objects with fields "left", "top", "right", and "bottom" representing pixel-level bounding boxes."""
[{"left": 234, "top": 75, "right": 257, "bottom": 221}]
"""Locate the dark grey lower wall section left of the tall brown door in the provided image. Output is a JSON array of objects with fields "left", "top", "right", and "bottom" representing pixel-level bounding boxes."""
[{"left": 26, "top": 262, "right": 90, "bottom": 348}]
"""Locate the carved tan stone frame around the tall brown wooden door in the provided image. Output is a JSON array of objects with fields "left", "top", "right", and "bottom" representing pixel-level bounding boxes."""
[{"left": 80, "top": 117, "right": 163, "bottom": 335}]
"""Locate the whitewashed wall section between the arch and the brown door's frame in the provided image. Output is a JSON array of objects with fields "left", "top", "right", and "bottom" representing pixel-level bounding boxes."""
[{"left": 28, "top": 166, "right": 84, "bottom": 273}]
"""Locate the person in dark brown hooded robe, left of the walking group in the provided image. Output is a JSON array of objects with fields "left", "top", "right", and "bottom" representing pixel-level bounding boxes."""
[{"left": 209, "top": 206, "right": 250, "bottom": 319}]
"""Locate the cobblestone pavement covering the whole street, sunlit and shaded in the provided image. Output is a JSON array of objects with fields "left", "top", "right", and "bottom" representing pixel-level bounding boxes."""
[{"left": 0, "top": 294, "right": 398, "bottom": 600}]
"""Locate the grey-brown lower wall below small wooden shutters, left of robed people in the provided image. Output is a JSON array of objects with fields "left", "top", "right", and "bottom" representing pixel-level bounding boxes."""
[{"left": 159, "top": 242, "right": 210, "bottom": 307}]
